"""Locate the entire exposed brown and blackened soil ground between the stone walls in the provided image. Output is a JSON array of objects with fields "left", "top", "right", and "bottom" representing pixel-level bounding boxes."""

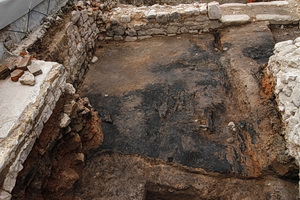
[{"left": 76, "top": 23, "right": 298, "bottom": 199}]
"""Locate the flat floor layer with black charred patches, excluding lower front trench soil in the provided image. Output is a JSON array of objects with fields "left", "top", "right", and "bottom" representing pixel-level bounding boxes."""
[{"left": 81, "top": 23, "right": 292, "bottom": 176}]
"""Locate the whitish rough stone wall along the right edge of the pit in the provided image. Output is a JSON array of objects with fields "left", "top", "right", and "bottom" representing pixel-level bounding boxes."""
[{"left": 268, "top": 38, "right": 300, "bottom": 193}]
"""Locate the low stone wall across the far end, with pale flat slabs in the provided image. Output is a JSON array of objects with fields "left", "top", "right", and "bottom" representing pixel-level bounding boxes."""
[{"left": 100, "top": 1, "right": 299, "bottom": 41}]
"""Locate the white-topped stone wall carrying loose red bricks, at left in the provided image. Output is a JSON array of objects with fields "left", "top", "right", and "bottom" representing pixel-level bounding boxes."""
[{"left": 0, "top": 61, "right": 67, "bottom": 199}]
